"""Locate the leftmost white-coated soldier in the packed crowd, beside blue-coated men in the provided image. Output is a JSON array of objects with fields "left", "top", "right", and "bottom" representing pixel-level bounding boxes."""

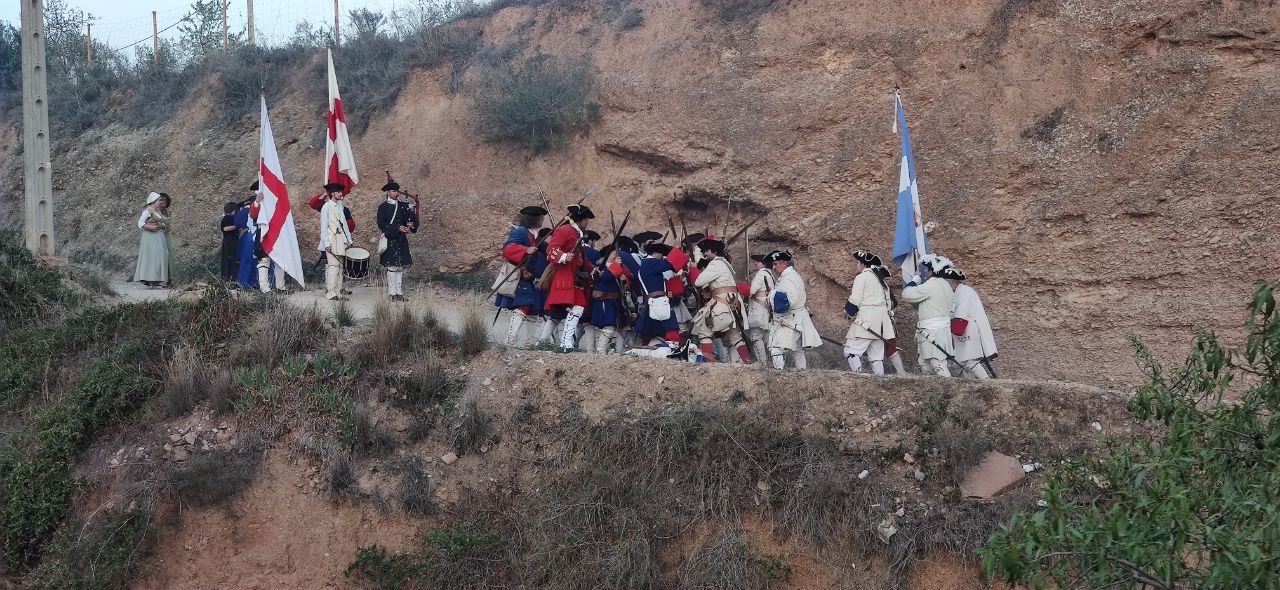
[{"left": 692, "top": 239, "right": 751, "bottom": 365}]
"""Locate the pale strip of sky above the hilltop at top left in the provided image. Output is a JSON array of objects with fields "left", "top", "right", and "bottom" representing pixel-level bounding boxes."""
[{"left": 0, "top": 0, "right": 434, "bottom": 47}]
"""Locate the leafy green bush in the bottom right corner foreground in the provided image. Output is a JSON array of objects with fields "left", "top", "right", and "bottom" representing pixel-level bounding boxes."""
[{"left": 982, "top": 282, "right": 1280, "bottom": 589}]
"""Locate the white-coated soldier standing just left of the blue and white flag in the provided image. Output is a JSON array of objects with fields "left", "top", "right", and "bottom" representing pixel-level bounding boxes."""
[{"left": 845, "top": 250, "right": 893, "bottom": 375}]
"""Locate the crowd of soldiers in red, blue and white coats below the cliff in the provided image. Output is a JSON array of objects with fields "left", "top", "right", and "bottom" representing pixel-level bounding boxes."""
[{"left": 493, "top": 205, "right": 996, "bottom": 379}]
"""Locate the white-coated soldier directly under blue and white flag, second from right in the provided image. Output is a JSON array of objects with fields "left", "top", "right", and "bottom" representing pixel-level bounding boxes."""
[{"left": 902, "top": 250, "right": 955, "bottom": 376}]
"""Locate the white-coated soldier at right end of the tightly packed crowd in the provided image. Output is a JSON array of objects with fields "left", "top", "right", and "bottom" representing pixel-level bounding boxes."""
[{"left": 768, "top": 251, "right": 822, "bottom": 369}]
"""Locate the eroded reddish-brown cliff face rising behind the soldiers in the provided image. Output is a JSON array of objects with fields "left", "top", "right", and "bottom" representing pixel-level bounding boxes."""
[{"left": 0, "top": 0, "right": 1280, "bottom": 384}]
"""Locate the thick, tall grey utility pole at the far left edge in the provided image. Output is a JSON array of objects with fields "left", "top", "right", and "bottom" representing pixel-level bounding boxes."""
[{"left": 22, "top": 0, "right": 54, "bottom": 256}]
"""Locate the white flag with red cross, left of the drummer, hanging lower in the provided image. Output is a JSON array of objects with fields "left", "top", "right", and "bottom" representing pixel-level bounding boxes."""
[{"left": 257, "top": 96, "right": 305, "bottom": 285}]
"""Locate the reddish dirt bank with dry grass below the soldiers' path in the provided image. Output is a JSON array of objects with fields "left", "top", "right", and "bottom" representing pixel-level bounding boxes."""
[{"left": 127, "top": 351, "right": 1133, "bottom": 589}]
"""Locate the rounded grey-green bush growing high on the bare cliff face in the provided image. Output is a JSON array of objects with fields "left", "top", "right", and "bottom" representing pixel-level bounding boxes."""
[{"left": 472, "top": 55, "right": 600, "bottom": 154}]
